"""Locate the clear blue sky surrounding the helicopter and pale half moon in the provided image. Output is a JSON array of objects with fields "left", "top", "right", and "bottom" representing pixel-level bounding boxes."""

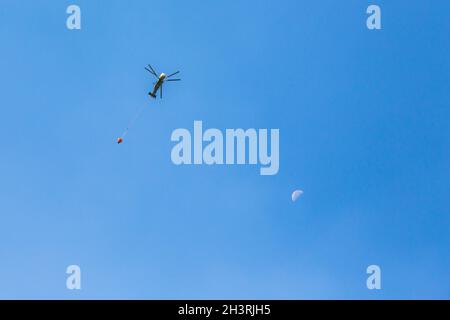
[{"left": 0, "top": 0, "right": 450, "bottom": 299}]
